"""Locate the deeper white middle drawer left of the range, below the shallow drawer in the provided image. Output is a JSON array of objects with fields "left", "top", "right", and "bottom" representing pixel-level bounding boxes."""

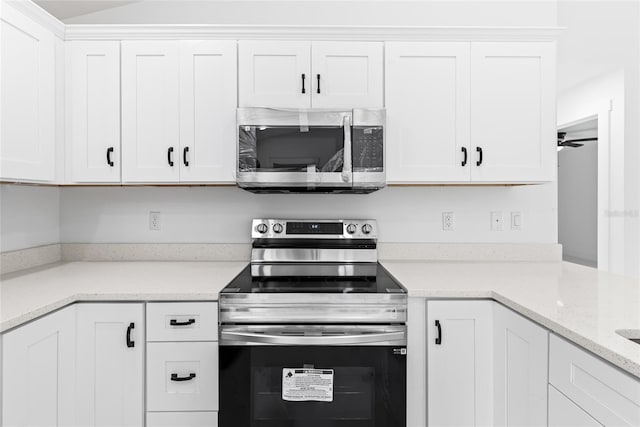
[{"left": 147, "top": 342, "right": 218, "bottom": 411}]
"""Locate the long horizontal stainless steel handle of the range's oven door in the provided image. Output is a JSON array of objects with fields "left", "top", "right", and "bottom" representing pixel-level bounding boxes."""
[{"left": 220, "top": 331, "right": 406, "bottom": 345}]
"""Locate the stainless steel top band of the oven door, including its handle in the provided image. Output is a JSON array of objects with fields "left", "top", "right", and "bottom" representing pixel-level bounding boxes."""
[{"left": 220, "top": 325, "right": 407, "bottom": 346}]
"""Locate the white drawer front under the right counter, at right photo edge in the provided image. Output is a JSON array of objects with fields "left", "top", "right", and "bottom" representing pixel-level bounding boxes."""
[{"left": 549, "top": 335, "right": 640, "bottom": 426}]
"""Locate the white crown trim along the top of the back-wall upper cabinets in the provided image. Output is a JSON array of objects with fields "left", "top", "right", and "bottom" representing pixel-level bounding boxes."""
[{"left": 65, "top": 24, "right": 563, "bottom": 42}]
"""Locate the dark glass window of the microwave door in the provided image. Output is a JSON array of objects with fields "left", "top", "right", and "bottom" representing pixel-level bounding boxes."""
[{"left": 238, "top": 126, "right": 344, "bottom": 173}]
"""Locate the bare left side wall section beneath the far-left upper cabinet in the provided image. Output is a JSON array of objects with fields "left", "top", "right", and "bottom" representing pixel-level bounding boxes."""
[{"left": 0, "top": 184, "right": 60, "bottom": 252}]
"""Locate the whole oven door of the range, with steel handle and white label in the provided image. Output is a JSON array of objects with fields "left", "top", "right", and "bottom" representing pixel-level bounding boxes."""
[{"left": 219, "top": 325, "right": 406, "bottom": 427}]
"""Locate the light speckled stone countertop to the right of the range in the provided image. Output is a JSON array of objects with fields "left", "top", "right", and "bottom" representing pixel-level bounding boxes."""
[{"left": 382, "top": 261, "right": 640, "bottom": 377}]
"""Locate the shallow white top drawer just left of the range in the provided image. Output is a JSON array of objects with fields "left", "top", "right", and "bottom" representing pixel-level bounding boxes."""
[{"left": 147, "top": 302, "right": 218, "bottom": 342}]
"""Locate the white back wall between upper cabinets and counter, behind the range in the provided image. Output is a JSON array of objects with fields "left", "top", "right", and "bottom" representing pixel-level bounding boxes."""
[{"left": 61, "top": 183, "right": 557, "bottom": 243}]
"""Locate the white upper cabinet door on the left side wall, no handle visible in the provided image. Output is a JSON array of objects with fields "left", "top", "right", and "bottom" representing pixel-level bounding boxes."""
[{"left": 0, "top": 2, "right": 55, "bottom": 181}]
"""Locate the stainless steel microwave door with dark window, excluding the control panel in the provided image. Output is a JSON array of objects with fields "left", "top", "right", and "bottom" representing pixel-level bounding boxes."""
[{"left": 236, "top": 108, "right": 353, "bottom": 189}]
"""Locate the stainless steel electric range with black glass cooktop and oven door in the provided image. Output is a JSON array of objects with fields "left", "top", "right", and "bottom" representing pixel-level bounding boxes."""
[{"left": 219, "top": 219, "right": 407, "bottom": 427}]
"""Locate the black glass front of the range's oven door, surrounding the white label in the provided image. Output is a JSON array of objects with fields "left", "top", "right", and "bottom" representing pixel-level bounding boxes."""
[{"left": 219, "top": 346, "right": 406, "bottom": 427}]
